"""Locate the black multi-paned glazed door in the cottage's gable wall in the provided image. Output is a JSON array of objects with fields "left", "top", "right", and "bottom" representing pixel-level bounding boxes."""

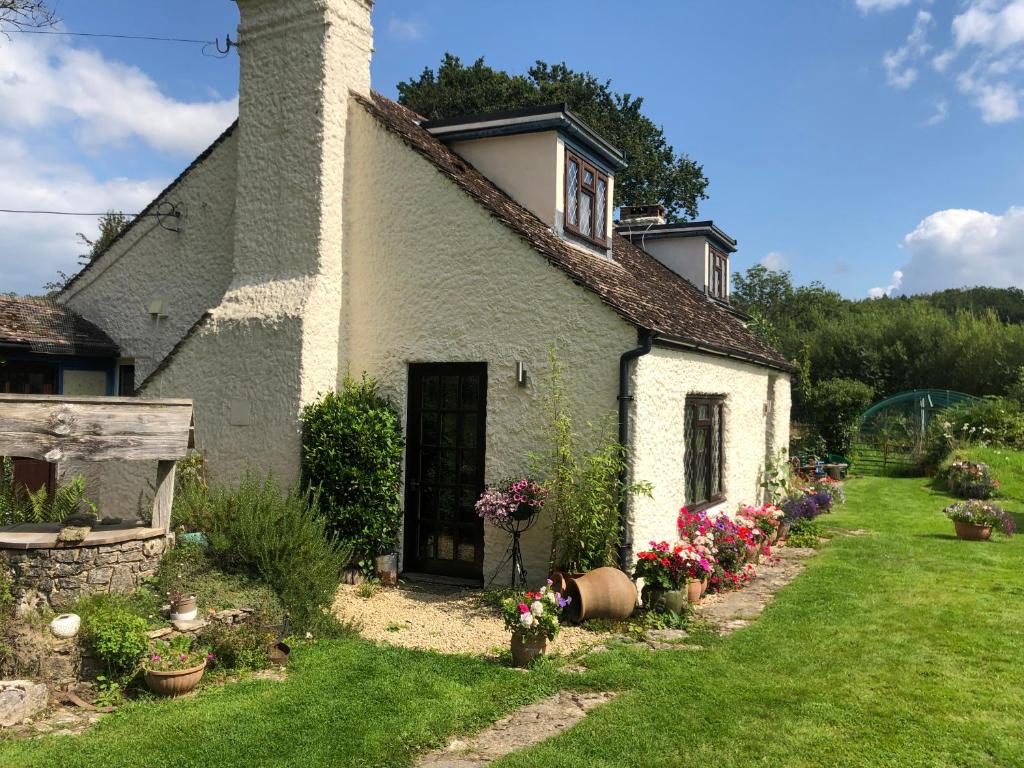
[{"left": 404, "top": 362, "right": 487, "bottom": 579}]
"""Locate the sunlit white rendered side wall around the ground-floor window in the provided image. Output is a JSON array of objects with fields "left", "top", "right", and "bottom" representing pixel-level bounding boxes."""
[{"left": 632, "top": 347, "right": 790, "bottom": 553}]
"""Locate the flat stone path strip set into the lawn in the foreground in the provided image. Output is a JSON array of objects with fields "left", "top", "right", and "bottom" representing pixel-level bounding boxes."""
[{"left": 416, "top": 690, "right": 615, "bottom": 768}]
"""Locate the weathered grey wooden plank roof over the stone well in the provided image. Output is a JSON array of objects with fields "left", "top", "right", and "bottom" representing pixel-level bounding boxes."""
[{"left": 0, "top": 395, "right": 193, "bottom": 462}]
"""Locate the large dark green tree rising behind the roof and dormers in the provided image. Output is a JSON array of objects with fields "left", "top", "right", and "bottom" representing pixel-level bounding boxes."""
[{"left": 398, "top": 53, "right": 708, "bottom": 221}]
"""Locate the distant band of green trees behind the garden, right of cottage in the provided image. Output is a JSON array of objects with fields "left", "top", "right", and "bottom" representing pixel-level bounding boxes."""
[{"left": 732, "top": 266, "right": 1024, "bottom": 447}]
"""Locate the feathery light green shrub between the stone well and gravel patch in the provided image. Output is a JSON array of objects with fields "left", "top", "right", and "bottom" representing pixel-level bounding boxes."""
[{"left": 202, "top": 473, "right": 352, "bottom": 632}]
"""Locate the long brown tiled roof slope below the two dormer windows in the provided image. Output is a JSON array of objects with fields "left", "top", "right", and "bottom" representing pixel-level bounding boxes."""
[{"left": 353, "top": 93, "right": 792, "bottom": 370}]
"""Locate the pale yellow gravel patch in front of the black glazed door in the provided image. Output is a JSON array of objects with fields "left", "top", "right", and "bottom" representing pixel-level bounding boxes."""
[{"left": 334, "top": 584, "right": 610, "bottom": 657}]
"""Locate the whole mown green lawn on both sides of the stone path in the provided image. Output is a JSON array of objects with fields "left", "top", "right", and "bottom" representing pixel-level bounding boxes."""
[{"left": 0, "top": 473, "right": 1024, "bottom": 768}]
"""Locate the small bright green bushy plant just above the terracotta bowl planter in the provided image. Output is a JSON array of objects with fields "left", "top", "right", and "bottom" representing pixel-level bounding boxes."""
[{"left": 79, "top": 595, "right": 150, "bottom": 676}]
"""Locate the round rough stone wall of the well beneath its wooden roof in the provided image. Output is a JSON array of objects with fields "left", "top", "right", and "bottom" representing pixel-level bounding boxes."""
[{"left": 0, "top": 528, "right": 167, "bottom": 612}]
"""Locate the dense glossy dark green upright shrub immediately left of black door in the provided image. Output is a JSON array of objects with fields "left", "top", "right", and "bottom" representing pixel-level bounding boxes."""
[{"left": 301, "top": 375, "right": 404, "bottom": 560}]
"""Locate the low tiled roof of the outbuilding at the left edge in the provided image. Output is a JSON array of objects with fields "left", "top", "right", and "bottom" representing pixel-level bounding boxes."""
[{"left": 0, "top": 296, "right": 119, "bottom": 357}]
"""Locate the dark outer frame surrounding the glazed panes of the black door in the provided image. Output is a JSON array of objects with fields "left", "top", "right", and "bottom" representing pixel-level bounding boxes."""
[{"left": 402, "top": 362, "right": 487, "bottom": 581}]
